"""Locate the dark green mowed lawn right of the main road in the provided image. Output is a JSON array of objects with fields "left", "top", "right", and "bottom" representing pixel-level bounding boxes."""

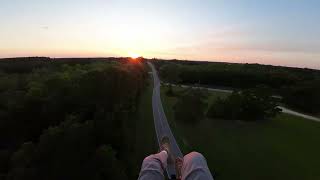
[{"left": 161, "top": 87, "right": 320, "bottom": 180}]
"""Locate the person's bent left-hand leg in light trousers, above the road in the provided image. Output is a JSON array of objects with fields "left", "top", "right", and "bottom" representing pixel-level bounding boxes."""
[{"left": 138, "top": 150, "right": 168, "bottom": 180}]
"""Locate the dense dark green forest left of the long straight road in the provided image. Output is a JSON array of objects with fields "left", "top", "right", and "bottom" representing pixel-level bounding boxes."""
[{"left": 0, "top": 57, "right": 147, "bottom": 180}]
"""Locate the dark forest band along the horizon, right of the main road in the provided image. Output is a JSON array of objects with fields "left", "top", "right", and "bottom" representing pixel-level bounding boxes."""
[{"left": 153, "top": 60, "right": 320, "bottom": 115}]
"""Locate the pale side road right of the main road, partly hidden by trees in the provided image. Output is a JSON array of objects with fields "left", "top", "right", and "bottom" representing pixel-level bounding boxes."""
[{"left": 167, "top": 83, "right": 320, "bottom": 122}]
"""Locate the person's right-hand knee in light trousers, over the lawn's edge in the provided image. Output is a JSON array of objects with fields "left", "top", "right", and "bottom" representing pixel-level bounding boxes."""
[{"left": 181, "top": 152, "right": 213, "bottom": 180}]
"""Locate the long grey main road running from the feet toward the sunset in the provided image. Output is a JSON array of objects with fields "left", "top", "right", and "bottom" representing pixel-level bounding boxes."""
[{"left": 148, "top": 62, "right": 183, "bottom": 178}]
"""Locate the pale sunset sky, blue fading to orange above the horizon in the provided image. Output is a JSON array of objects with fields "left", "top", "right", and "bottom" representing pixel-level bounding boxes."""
[{"left": 0, "top": 0, "right": 320, "bottom": 69}]
